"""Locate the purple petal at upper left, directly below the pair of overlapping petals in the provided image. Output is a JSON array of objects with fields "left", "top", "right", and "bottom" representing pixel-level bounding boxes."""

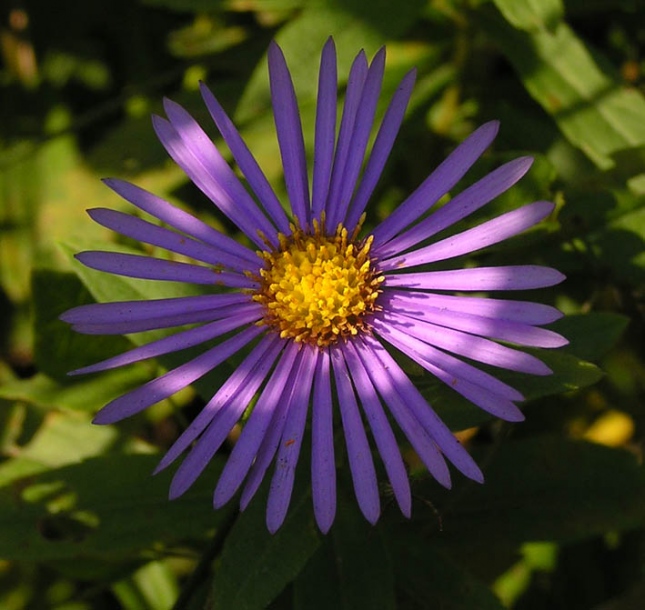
[{"left": 103, "top": 178, "right": 258, "bottom": 271}]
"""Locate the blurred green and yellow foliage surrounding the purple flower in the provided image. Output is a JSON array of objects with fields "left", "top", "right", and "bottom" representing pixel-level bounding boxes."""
[{"left": 0, "top": 0, "right": 645, "bottom": 610}]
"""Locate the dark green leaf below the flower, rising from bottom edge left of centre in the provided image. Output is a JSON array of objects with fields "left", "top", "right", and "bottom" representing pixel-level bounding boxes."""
[{"left": 212, "top": 480, "right": 321, "bottom": 610}]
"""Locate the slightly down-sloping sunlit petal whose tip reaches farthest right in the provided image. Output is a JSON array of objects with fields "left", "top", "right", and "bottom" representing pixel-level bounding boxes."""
[{"left": 379, "top": 291, "right": 567, "bottom": 348}]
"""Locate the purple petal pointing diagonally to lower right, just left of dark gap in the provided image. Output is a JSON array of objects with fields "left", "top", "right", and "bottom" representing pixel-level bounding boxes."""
[{"left": 361, "top": 335, "right": 484, "bottom": 483}]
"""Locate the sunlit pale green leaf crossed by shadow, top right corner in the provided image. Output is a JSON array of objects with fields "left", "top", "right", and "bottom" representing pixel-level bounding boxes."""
[{"left": 478, "top": 9, "right": 645, "bottom": 169}]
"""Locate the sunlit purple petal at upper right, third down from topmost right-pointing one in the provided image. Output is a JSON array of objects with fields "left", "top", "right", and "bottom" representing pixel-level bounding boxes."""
[{"left": 379, "top": 201, "right": 555, "bottom": 271}]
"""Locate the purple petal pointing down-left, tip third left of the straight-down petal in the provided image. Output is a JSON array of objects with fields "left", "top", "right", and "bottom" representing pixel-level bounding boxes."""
[{"left": 213, "top": 343, "right": 298, "bottom": 508}]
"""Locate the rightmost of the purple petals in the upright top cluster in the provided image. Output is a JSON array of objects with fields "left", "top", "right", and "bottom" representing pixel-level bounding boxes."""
[{"left": 345, "top": 70, "right": 416, "bottom": 230}]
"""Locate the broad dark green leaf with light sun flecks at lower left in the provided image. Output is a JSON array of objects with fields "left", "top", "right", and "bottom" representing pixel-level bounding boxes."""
[{"left": 0, "top": 455, "right": 226, "bottom": 561}]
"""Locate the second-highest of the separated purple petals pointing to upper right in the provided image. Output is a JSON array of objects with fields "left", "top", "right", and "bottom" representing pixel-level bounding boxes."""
[{"left": 375, "top": 157, "right": 533, "bottom": 258}]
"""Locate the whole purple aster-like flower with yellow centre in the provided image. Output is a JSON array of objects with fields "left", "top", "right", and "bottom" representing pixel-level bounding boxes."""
[{"left": 62, "top": 39, "right": 566, "bottom": 532}]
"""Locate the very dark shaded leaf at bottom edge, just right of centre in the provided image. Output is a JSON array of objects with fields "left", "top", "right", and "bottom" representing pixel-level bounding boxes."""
[{"left": 388, "top": 528, "right": 504, "bottom": 610}]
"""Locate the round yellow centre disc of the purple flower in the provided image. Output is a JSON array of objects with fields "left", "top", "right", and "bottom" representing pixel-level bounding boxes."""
[{"left": 253, "top": 220, "right": 384, "bottom": 347}]
